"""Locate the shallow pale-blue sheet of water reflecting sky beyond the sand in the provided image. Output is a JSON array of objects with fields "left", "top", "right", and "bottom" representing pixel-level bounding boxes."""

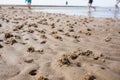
[{"left": 33, "top": 7, "right": 120, "bottom": 19}]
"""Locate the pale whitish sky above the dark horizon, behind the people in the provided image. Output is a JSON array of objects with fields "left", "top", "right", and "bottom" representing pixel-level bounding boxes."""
[{"left": 0, "top": 0, "right": 116, "bottom": 7}]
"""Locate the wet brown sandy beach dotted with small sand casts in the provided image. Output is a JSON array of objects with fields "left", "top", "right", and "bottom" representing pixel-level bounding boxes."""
[{"left": 0, "top": 7, "right": 120, "bottom": 80}]
